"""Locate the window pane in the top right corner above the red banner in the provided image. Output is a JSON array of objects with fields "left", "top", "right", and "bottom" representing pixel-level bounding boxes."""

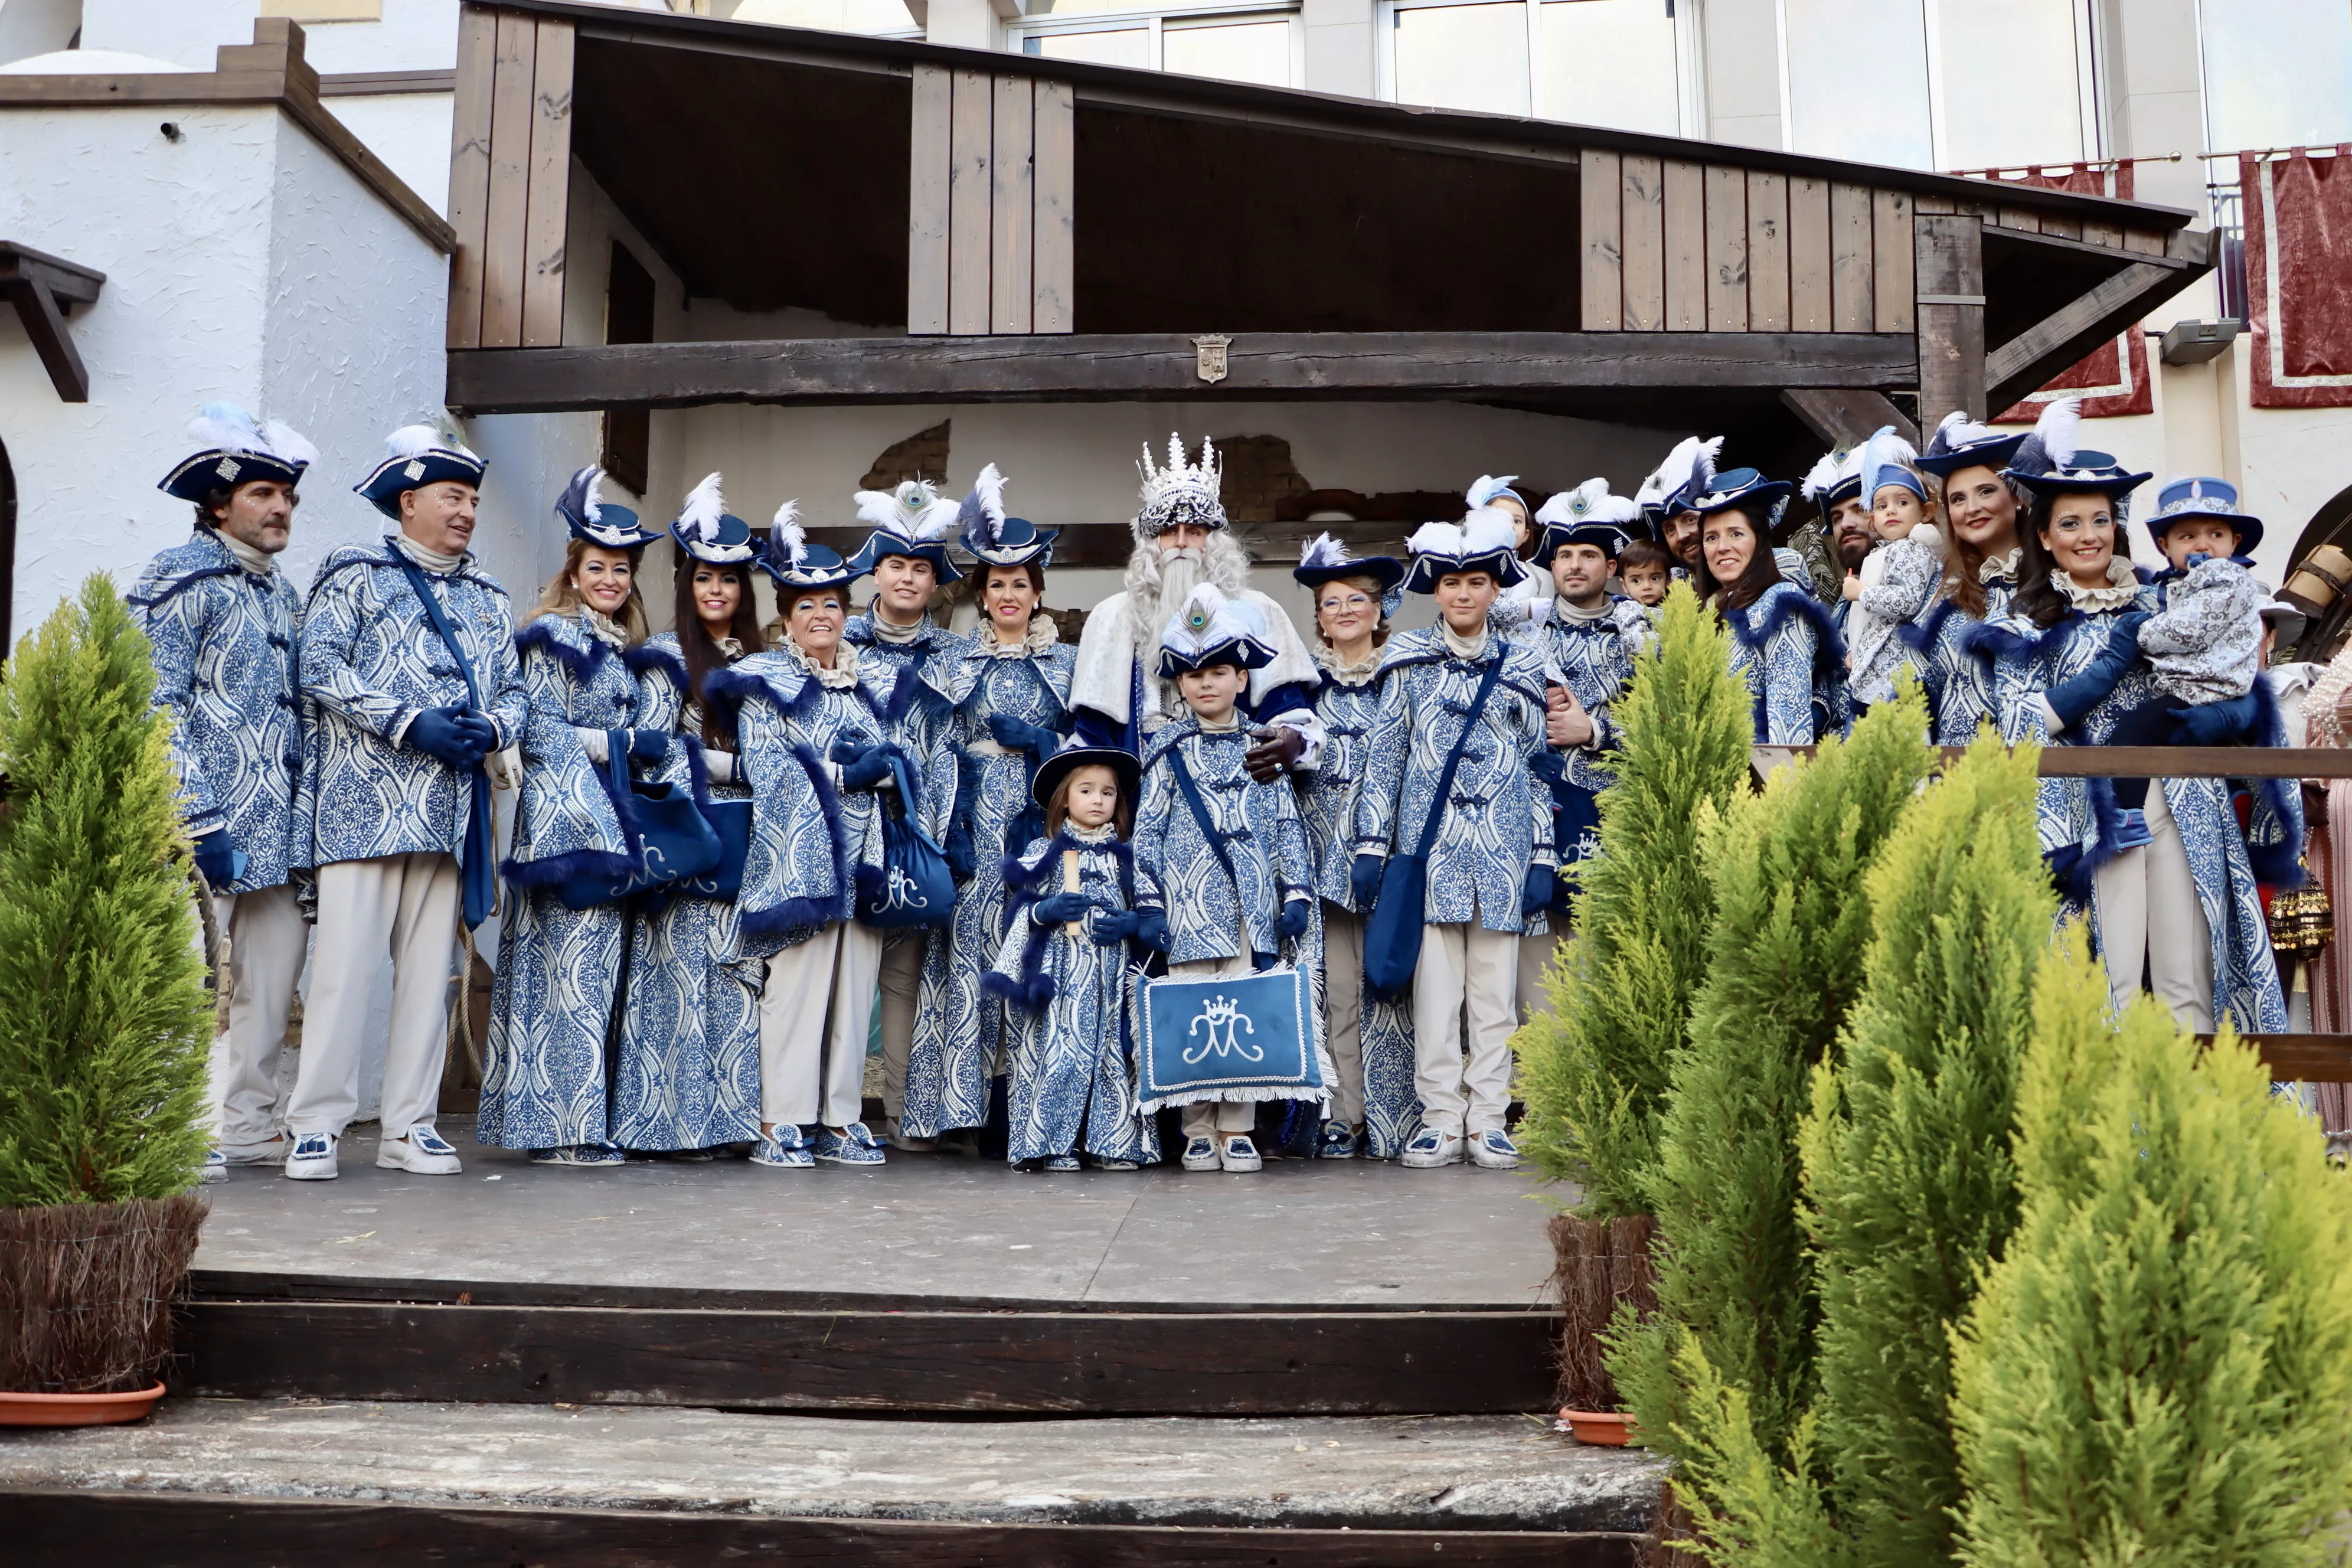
[{"left": 2204, "top": 0, "right": 2352, "bottom": 153}]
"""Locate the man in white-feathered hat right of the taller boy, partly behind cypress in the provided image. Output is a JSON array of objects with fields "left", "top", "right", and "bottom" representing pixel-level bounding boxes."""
[{"left": 1517, "top": 479, "right": 1654, "bottom": 1023}]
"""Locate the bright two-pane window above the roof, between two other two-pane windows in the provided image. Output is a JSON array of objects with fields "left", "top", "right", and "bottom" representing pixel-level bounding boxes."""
[{"left": 1381, "top": 0, "right": 1693, "bottom": 136}]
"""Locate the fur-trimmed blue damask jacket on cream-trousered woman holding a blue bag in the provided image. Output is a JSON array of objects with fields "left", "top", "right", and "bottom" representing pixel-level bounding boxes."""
[{"left": 703, "top": 644, "right": 899, "bottom": 957}]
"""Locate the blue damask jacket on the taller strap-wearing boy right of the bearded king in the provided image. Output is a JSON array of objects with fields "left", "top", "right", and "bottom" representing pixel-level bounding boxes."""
[{"left": 1355, "top": 625, "right": 1554, "bottom": 931}]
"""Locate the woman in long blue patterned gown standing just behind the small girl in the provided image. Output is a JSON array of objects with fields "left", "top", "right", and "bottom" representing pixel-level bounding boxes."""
[{"left": 899, "top": 494, "right": 1077, "bottom": 1138}]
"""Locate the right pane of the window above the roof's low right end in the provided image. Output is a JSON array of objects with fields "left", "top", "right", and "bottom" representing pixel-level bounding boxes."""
[{"left": 1941, "top": 0, "right": 2091, "bottom": 169}]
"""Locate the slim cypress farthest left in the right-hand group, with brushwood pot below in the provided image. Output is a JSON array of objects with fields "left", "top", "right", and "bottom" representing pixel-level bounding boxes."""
[{"left": 1515, "top": 583, "right": 1755, "bottom": 1218}]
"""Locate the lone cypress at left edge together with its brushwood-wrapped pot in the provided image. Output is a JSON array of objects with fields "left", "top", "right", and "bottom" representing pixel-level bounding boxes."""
[{"left": 0, "top": 574, "right": 212, "bottom": 1425}]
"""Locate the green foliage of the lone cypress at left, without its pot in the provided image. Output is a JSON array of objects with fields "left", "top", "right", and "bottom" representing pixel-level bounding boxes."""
[{"left": 0, "top": 574, "right": 212, "bottom": 1208}]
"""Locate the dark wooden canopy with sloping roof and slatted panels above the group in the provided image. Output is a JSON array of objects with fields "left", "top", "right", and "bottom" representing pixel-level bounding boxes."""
[{"left": 449, "top": 0, "right": 2209, "bottom": 465}]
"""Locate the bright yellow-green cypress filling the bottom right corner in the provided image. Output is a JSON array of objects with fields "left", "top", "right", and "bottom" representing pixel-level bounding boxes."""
[{"left": 1952, "top": 933, "right": 2352, "bottom": 1568}]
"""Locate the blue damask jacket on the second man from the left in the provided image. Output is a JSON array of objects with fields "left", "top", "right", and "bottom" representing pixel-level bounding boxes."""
[{"left": 301, "top": 536, "right": 529, "bottom": 865}]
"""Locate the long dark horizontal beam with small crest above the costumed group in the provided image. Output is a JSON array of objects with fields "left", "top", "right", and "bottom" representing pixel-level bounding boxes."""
[{"left": 447, "top": 331, "right": 1919, "bottom": 414}]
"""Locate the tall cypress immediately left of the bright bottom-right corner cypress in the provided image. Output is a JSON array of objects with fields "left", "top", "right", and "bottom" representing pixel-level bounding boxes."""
[{"left": 1675, "top": 738, "right": 2056, "bottom": 1568}]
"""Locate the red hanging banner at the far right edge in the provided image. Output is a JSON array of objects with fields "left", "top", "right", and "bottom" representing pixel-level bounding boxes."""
[{"left": 2237, "top": 143, "right": 2352, "bottom": 409}]
